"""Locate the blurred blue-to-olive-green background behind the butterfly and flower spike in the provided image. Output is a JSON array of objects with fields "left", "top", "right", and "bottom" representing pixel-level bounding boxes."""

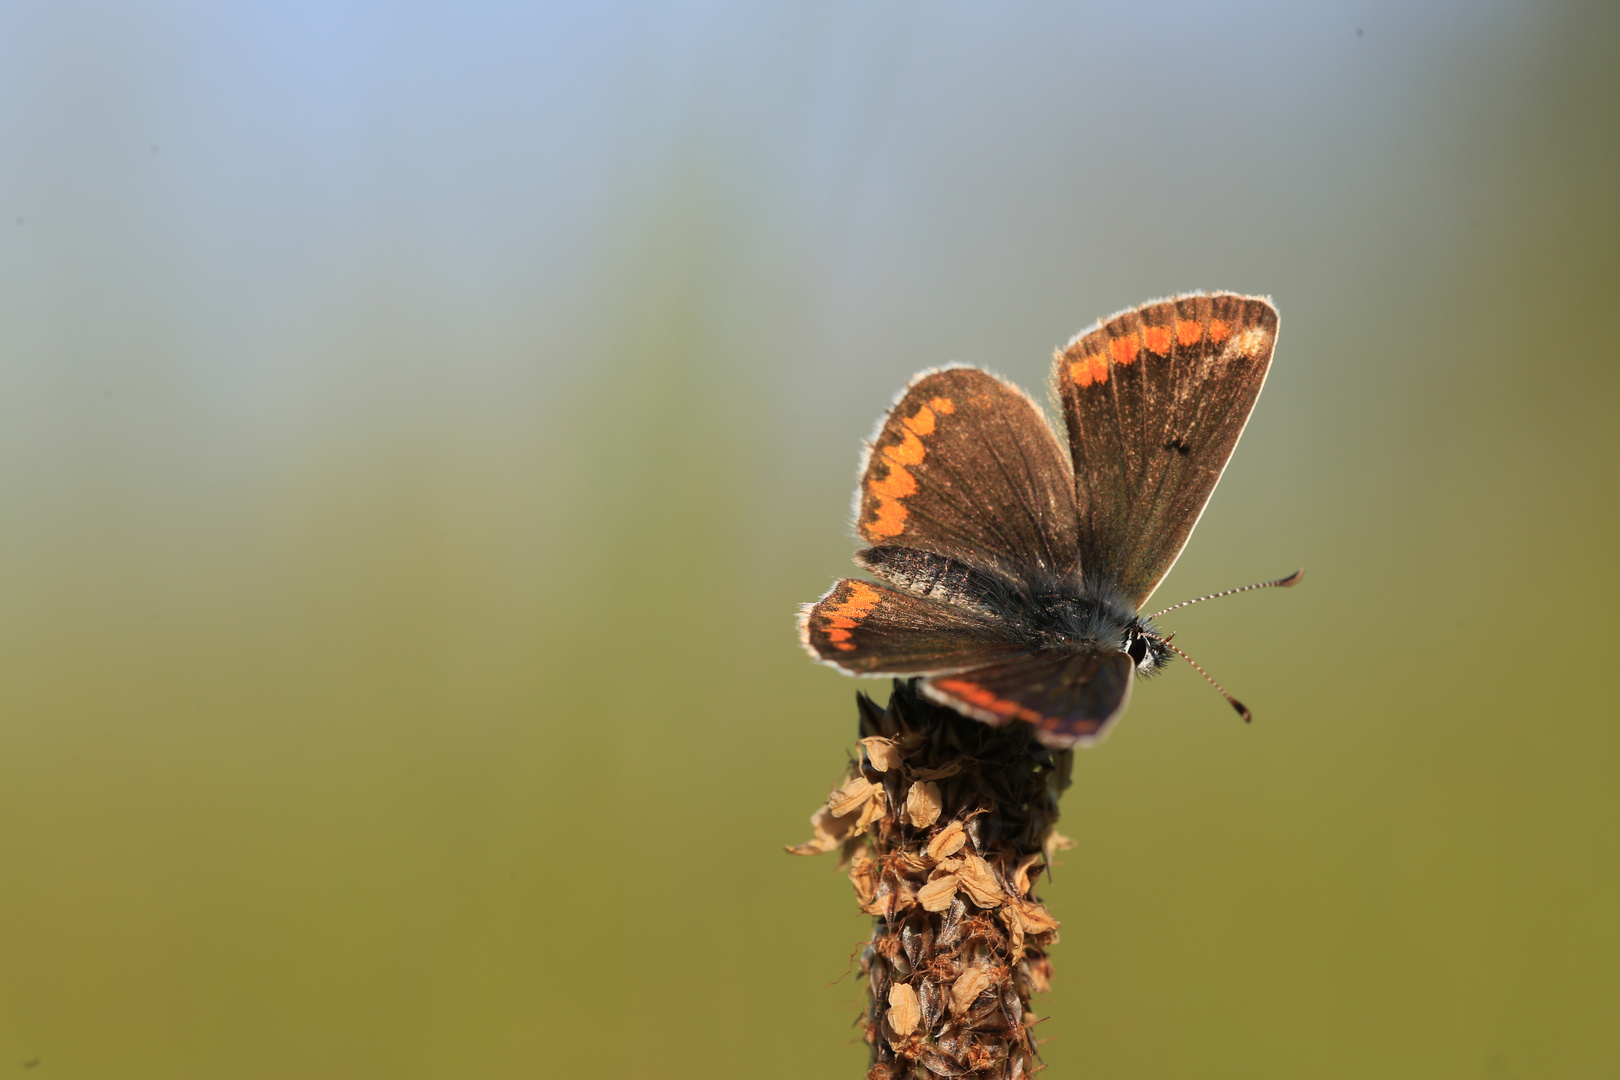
[{"left": 0, "top": 0, "right": 1620, "bottom": 1080}]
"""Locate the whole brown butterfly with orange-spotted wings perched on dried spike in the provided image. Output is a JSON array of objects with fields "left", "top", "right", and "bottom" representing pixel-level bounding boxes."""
[{"left": 799, "top": 293, "right": 1301, "bottom": 748}]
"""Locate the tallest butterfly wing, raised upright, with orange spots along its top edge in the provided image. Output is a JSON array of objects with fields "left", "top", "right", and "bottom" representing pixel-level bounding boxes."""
[{"left": 1053, "top": 293, "right": 1277, "bottom": 607}]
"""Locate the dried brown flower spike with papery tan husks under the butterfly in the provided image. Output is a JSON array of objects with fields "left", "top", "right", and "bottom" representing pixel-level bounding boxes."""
[{"left": 789, "top": 682, "right": 1071, "bottom": 1080}]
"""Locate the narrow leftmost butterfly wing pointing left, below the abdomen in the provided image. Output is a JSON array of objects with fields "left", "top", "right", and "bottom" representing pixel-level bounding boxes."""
[{"left": 799, "top": 578, "right": 1025, "bottom": 675}]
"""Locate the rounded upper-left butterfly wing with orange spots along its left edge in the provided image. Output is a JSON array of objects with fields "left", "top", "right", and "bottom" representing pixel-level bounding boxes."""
[{"left": 855, "top": 368, "right": 1076, "bottom": 580}]
